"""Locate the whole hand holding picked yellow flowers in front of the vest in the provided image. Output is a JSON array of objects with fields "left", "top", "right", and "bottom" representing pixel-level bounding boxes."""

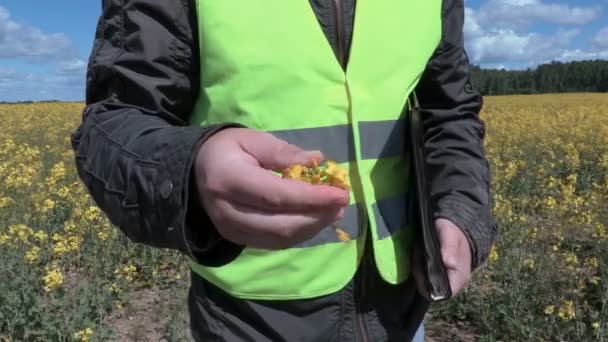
[{"left": 195, "top": 128, "right": 349, "bottom": 249}]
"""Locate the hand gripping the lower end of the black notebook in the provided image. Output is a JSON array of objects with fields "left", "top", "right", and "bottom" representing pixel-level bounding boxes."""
[{"left": 414, "top": 218, "right": 471, "bottom": 298}]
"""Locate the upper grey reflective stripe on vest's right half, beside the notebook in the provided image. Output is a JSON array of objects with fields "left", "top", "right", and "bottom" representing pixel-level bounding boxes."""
[{"left": 359, "top": 119, "right": 409, "bottom": 159}]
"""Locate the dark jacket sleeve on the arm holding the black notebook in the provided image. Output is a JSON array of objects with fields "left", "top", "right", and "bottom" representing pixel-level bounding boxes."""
[{"left": 416, "top": 0, "right": 496, "bottom": 268}]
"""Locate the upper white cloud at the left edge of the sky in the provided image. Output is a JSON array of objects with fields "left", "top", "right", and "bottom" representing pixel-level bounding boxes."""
[{"left": 0, "top": 6, "right": 77, "bottom": 62}]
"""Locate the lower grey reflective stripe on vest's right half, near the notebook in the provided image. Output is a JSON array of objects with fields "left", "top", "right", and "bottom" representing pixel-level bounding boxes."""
[{"left": 372, "top": 192, "right": 415, "bottom": 240}]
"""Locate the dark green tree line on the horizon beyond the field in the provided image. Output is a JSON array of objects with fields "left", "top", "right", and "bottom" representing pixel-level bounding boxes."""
[{"left": 471, "top": 60, "right": 608, "bottom": 95}]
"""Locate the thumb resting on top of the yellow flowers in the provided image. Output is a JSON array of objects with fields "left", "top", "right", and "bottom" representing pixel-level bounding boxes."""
[{"left": 239, "top": 132, "right": 323, "bottom": 171}]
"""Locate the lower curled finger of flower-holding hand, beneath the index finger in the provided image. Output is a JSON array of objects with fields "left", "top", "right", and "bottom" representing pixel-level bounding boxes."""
[{"left": 210, "top": 200, "right": 344, "bottom": 249}]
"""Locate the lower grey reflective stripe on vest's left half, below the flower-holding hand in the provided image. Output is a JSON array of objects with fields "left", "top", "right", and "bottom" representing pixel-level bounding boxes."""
[{"left": 293, "top": 204, "right": 363, "bottom": 248}]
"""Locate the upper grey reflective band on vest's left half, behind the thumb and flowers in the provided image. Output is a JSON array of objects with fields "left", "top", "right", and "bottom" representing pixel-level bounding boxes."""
[{"left": 268, "top": 125, "right": 355, "bottom": 163}]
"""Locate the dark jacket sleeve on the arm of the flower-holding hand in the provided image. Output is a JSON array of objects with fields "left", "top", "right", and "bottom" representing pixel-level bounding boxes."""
[{"left": 72, "top": 0, "right": 247, "bottom": 265}]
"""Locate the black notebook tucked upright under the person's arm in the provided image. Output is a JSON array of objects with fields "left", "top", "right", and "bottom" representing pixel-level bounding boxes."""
[{"left": 408, "top": 93, "right": 452, "bottom": 302}]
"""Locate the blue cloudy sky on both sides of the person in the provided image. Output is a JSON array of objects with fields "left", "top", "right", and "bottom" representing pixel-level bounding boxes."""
[{"left": 0, "top": 0, "right": 608, "bottom": 101}]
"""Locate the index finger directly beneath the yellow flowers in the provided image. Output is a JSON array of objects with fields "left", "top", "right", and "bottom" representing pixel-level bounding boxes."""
[{"left": 217, "top": 160, "right": 349, "bottom": 212}]
